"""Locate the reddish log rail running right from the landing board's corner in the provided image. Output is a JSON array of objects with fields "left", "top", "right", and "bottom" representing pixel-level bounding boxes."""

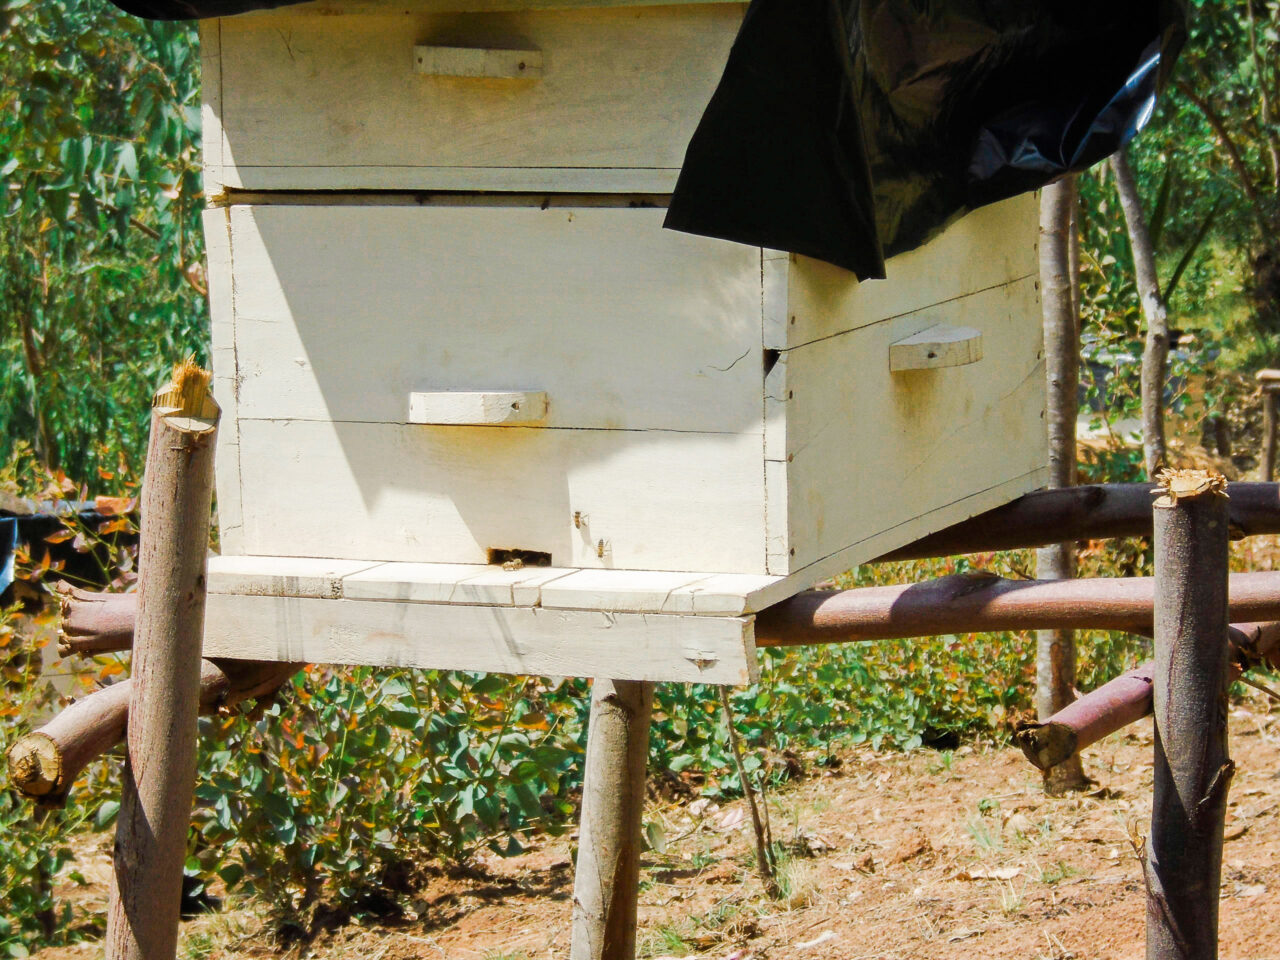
[{"left": 755, "top": 571, "right": 1280, "bottom": 646}]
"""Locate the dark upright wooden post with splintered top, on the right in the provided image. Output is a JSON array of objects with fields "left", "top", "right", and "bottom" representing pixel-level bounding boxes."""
[{"left": 1143, "top": 470, "right": 1235, "bottom": 960}]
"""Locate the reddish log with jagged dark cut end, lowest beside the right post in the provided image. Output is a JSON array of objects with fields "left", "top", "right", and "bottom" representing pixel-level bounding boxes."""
[{"left": 1014, "top": 622, "right": 1280, "bottom": 771}]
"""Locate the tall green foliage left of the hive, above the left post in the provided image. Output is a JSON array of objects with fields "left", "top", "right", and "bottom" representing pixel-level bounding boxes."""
[{"left": 0, "top": 0, "right": 207, "bottom": 477}]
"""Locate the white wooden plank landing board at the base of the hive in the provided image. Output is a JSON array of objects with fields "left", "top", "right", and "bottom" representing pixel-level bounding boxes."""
[{"left": 204, "top": 557, "right": 762, "bottom": 685}]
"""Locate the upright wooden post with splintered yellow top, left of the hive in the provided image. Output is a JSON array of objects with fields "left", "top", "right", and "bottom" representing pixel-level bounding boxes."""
[{"left": 105, "top": 361, "right": 219, "bottom": 960}]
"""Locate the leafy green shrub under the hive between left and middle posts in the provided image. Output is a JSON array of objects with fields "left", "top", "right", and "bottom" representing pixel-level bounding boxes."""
[{"left": 196, "top": 667, "right": 582, "bottom": 925}]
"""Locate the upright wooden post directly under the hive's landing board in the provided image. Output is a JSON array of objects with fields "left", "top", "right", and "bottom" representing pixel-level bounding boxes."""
[{"left": 570, "top": 680, "right": 653, "bottom": 960}]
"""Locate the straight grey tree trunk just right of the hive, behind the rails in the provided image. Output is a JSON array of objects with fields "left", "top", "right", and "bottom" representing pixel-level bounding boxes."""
[{"left": 1036, "top": 177, "right": 1089, "bottom": 794}]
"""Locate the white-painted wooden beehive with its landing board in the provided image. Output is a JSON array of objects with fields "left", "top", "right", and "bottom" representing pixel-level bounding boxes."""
[{"left": 202, "top": 0, "right": 1046, "bottom": 682}]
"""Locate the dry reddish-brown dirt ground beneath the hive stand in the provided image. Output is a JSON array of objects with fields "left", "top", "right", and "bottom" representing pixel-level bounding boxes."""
[{"left": 32, "top": 700, "right": 1280, "bottom": 960}]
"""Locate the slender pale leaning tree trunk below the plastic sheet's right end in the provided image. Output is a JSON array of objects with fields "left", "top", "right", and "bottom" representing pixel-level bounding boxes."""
[{"left": 1111, "top": 150, "right": 1169, "bottom": 477}]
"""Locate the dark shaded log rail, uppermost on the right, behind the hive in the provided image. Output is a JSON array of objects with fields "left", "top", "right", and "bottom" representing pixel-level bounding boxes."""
[{"left": 873, "top": 483, "right": 1280, "bottom": 563}]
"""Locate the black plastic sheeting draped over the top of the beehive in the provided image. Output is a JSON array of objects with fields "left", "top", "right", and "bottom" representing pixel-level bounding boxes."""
[{"left": 104, "top": 0, "right": 1185, "bottom": 279}]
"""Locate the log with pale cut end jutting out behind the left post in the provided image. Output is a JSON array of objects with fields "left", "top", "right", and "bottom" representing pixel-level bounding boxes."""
[{"left": 8, "top": 660, "right": 302, "bottom": 805}]
